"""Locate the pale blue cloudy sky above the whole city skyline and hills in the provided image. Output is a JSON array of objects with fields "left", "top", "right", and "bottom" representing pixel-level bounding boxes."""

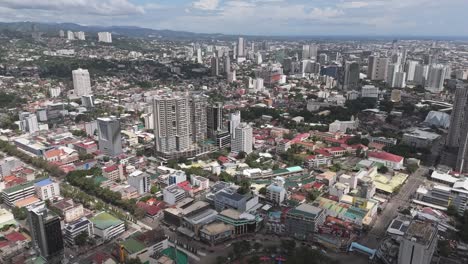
[{"left": 0, "top": 0, "right": 468, "bottom": 36}]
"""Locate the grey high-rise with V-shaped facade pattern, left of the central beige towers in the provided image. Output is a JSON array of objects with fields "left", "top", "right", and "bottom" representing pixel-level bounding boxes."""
[{"left": 97, "top": 116, "right": 122, "bottom": 156}]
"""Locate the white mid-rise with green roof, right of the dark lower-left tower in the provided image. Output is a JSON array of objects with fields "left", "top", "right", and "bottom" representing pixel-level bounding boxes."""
[{"left": 90, "top": 212, "right": 125, "bottom": 241}]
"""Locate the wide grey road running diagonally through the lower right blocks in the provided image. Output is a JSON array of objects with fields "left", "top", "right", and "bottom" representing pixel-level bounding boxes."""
[{"left": 359, "top": 166, "right": 429, "bottom": 248}]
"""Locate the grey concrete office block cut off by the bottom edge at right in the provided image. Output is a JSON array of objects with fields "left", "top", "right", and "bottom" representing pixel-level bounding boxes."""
[{"left": 398, "top": 220, "right": 438, "bottom": 264}]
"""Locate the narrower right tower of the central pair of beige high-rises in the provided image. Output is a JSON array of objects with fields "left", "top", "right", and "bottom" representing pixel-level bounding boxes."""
[{"left": 190, "top": 94, "right": 208, "bottom": 143}]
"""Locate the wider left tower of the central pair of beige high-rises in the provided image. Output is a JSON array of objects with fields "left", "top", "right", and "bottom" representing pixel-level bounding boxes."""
[{"left": 153, "top": 95, "right": 191, "bottom": 152}]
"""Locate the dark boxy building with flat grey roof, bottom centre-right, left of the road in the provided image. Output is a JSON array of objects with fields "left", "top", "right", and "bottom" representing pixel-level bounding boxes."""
[{"left": 285, "top": 203, "right": 325, "bottom": 240}]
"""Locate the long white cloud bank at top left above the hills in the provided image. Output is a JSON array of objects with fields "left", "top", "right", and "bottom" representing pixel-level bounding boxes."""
[{"left": 0, "top": 0, "right": 145, "bottom": 16}]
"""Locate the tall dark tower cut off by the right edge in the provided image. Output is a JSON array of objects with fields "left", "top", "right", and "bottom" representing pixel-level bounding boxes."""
[{"left": 445, "top": 83, "right": 468, "bottom": 148}]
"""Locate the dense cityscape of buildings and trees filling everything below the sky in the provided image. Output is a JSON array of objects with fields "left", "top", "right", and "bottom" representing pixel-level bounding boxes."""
[{"left": 0, "top": 9, "right": 468, "bottom": 264}]
